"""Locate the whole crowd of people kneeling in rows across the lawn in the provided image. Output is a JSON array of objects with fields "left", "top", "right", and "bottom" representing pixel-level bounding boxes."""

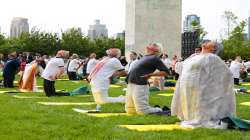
[{"left": 0, "top": 41, "right": 250, "bottom": 128}]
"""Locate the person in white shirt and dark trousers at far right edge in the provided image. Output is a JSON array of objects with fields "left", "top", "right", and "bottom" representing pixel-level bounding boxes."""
[{"left": 230, "top": 56, "right": 244, "bottom": 85}]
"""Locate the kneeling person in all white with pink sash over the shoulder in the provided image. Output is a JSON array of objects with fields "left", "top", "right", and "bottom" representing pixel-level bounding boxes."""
[{"left": 88, "top": 48, "right": 126, "bottom": 109}]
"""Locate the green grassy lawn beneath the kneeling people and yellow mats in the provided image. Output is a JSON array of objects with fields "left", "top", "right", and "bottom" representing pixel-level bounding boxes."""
[{"left": 0, "top": 79, "right": 250, "bottom": 140}]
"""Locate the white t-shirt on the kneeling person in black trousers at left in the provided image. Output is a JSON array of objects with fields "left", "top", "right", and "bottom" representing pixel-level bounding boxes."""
[{"left": 42, "top": 57, "right": 64, "bottom": 81}]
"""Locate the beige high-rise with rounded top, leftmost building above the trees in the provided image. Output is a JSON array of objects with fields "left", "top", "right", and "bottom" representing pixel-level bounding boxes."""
[{"left": 10, "top": 17, "right": 29, "bottom": 37}]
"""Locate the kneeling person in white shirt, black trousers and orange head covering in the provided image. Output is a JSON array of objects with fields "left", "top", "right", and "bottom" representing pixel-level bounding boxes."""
[{"left": 42, "top": 50, "right": 69, "bottom": 97}]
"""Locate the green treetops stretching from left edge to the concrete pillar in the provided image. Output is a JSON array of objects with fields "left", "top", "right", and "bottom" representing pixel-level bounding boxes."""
[{"left": 0, "top": 28, "right": 125, "bottom": 57}]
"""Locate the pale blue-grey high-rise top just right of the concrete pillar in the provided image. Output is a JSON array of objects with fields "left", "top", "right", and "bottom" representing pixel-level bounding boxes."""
[{"left": 183, "top": 15, "right": 200, "bottom": 32}]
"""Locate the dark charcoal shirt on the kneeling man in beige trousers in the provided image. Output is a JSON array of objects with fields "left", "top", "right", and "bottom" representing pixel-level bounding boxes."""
[{"left": 128, "top": 55, "right": 169, "bottom": 85}]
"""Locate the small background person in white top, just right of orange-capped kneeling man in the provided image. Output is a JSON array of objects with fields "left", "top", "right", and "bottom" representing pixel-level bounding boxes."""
[{"left": 68, "top": 53, "right": 82, "bottom": 80}]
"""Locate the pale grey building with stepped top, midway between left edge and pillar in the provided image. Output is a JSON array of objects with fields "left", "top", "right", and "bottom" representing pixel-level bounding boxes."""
[{"left": 88, "top": 20, "right": 108, "bottom": 39}]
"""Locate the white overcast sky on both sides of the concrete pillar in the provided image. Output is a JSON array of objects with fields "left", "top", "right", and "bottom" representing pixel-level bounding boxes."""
[{"left": 0, "top": 0, "right": 250, "bottom": 39}]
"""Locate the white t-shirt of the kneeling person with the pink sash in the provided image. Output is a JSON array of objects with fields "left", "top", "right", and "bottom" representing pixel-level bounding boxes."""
[{"left": 90, "top": 57, "right": 124, "bottom": 90}]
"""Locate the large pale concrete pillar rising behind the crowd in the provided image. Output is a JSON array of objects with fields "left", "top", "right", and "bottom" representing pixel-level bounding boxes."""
[{"left": 125, "top": 0, "right": 181, "bottom": 56}]
